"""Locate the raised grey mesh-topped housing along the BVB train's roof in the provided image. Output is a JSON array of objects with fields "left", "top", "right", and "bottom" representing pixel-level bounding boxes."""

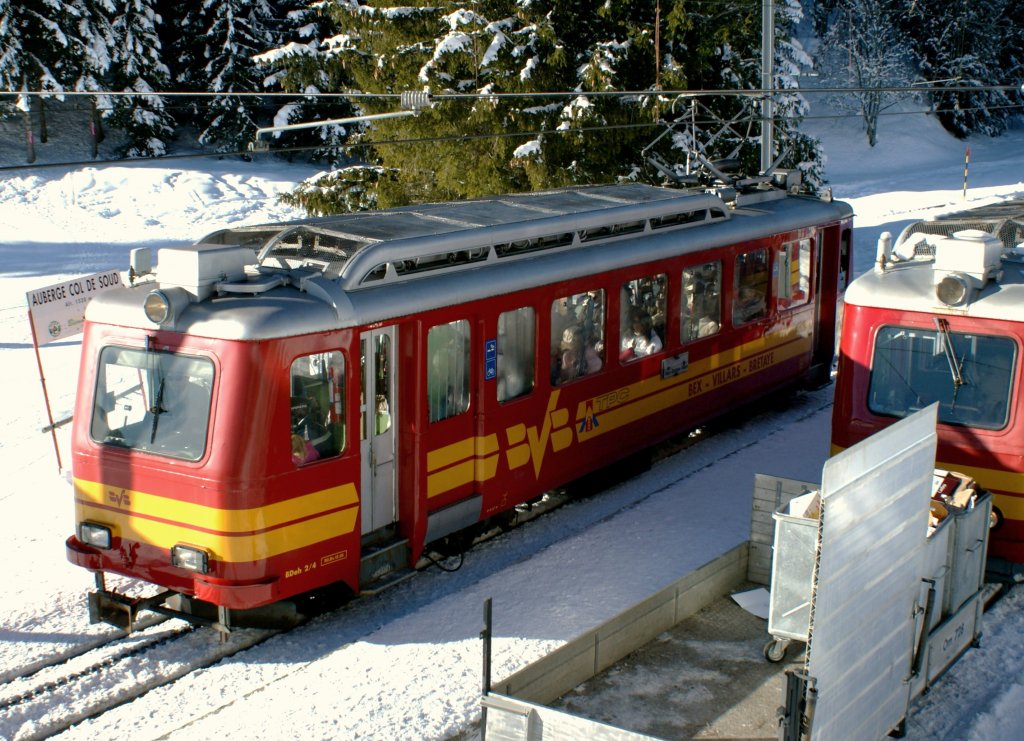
[{"left": 199, "top": 183, "right": 730, "bottom": 291}]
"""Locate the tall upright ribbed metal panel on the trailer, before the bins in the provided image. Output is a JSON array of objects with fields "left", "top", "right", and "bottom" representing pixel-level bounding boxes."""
[{"left": 806, "top": 405, "right": 937, "bottom": 739}]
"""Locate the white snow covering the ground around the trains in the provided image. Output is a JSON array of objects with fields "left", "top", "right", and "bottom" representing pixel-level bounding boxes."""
[{"left": 0, "top": 102, "right": 1024, "bottom": 739}]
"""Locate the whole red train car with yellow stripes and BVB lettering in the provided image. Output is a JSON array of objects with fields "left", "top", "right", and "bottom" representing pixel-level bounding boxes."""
[{"left": 67, "top": 183, "right": 852, "bottom": 623}]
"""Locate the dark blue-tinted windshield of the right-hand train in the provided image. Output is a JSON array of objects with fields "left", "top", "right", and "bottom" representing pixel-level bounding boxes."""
[{"left": 867, "top": 323, "right": 1017, "bottom": 430}]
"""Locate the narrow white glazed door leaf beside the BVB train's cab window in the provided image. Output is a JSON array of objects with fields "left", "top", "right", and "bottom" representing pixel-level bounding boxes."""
[{"left": 359, "top": 326, "right": 397, "bottom": 535}]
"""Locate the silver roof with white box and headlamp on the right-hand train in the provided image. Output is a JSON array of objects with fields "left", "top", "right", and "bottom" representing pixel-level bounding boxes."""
[{"left": 845, "top": 212, "right": 1024, "bottom": 321}]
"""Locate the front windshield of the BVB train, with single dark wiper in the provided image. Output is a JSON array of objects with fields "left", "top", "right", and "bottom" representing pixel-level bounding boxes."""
[{"left": 89, "top": 347, "right": 213, "bottom": 461}]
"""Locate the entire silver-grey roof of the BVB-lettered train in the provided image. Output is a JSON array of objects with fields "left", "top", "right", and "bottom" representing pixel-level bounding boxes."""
[{"left": 86, "top": 183, "right": 852, "bottom": 339}]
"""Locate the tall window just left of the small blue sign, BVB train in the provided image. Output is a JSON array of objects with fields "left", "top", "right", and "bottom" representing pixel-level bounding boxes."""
[{"left": 427, "top": 319, "right": 469, "bottom": 422}]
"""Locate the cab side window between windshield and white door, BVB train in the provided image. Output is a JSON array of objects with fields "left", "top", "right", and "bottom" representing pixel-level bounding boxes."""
[{"left": 289, "top": 350, "right": 345, "bottom": 466}]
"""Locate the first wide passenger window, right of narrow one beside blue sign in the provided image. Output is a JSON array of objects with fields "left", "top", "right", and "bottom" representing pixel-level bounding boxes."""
[{"left": 551, "top": 289, "right": 604, "bottom": 386}]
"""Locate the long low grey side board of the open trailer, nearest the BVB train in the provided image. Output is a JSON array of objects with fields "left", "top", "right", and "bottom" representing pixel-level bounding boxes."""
[{"left": 492, "top": 540, "right": 753, "bottom": 704}]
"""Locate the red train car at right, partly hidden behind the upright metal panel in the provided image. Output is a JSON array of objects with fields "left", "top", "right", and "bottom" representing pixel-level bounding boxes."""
[{"left": 831, "top": 209, "right": 1024, "bottom": 573}]
